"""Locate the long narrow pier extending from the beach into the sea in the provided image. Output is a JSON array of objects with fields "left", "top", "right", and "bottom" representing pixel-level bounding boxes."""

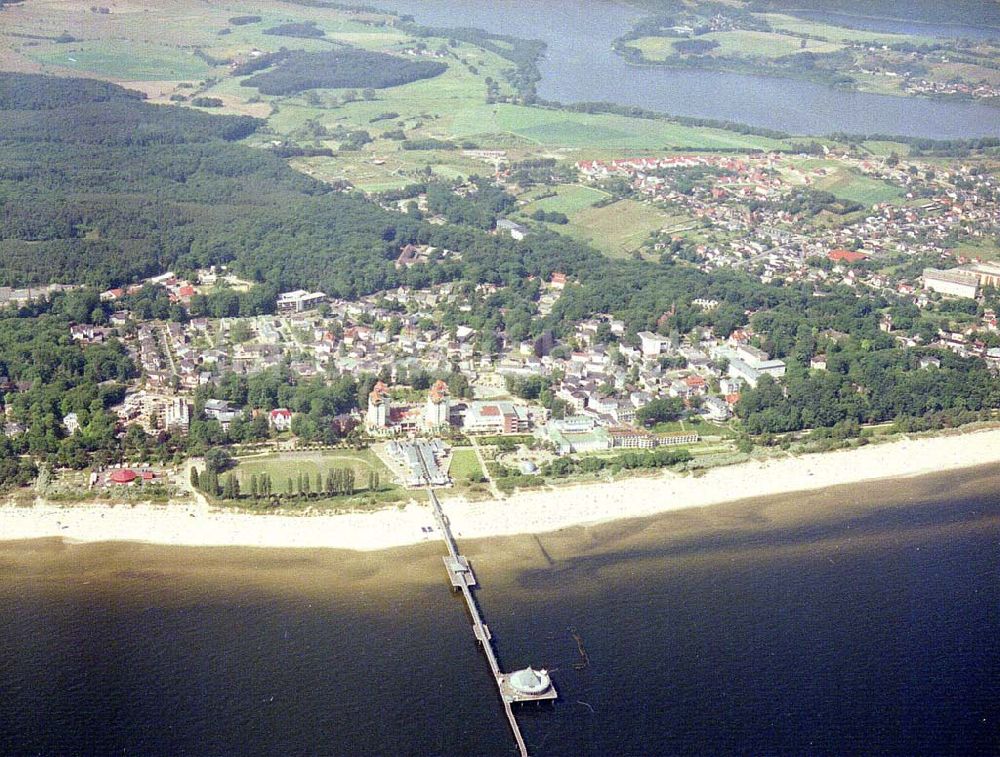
[{"left": 427, "top": 488, "right": 558, "bottom": 757}]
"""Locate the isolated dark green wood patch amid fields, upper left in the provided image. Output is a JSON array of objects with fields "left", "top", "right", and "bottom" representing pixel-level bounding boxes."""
[{"left": 240, "top": 48, "right": 448, "bottom": 95}]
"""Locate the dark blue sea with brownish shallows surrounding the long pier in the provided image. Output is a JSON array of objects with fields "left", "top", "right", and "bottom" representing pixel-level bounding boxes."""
[{"left": 0, "top": 470, "right": 1000, "bottom": 757}]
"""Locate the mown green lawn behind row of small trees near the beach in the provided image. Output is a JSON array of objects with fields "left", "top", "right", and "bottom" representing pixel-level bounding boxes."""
[{"left": 236, "top": 450, "right": 396, "bottom": 493}]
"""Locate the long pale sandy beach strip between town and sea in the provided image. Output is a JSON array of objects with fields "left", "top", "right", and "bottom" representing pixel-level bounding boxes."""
[{"left": 0, "top": 429, "right": 1000, "bottom": 551}]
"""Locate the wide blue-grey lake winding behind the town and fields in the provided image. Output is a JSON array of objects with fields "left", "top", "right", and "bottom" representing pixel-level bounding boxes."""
[{"left": 374, "top": 0, "right": 1000, "bottom": 139}]
